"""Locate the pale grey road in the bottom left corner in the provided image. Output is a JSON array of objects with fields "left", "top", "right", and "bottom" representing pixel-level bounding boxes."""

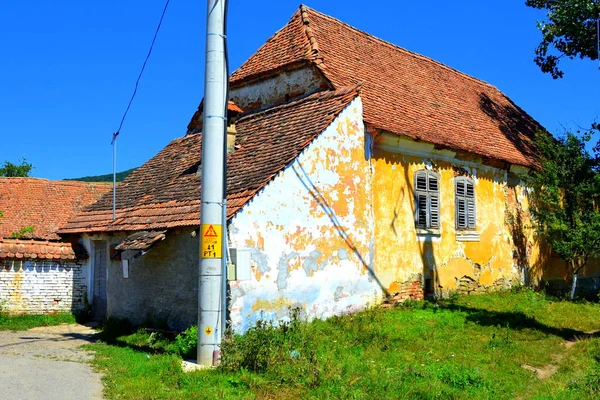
[{"left": 0, "top": 324, "right": 102, "bottom": 400}]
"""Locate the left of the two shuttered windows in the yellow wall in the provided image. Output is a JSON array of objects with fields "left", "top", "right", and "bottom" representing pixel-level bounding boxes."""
[{"left": 415, "top": 171, "right": 440, "bottom": 229}]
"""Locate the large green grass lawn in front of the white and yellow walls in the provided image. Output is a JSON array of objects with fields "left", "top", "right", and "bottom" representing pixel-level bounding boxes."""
[{"left": 90, "top": 290, "right": 600, "bottom": 399}]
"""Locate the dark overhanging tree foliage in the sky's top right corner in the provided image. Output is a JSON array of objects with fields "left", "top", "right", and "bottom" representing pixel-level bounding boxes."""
[{"left": 525, "top": 0, "right": 600, "bottom": 79}]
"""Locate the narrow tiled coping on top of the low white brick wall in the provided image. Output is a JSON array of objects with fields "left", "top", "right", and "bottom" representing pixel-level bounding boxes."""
[{"left": 0, "top": 239, "right": 88, "bottom": 261}]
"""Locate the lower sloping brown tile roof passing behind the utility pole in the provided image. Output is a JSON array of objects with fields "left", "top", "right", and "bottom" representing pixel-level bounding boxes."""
[{"left": 59, "top": 87, "right": 358, "bottom": 233}]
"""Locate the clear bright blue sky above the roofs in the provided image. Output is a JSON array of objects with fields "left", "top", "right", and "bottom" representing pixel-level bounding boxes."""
[{"left": 0, "top": 0, "right": 600, "bottom": 179}]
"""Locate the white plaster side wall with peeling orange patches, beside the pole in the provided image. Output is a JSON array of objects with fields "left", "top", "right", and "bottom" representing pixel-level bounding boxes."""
[{"left": 229, "top": 97, "right": 382, "bottom": 332}]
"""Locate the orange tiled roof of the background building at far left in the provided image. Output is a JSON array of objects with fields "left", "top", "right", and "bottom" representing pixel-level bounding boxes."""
[{"left": 0, "top": 178, "right": 111, "bottom": 240}]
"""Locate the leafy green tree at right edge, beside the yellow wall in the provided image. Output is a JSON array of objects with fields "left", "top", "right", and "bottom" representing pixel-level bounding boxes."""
[{"left": 526, "top": 131, "right": 600, "bottom": 298}]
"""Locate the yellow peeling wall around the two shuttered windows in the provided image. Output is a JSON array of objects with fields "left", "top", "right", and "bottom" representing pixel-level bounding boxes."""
[{"left": 373, "top": 134, "right": 539, "bottom": 295}]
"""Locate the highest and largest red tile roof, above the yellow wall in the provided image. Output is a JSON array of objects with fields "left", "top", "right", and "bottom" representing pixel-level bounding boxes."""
[{"left": 231, "top": 6, "right": 540, "bottom": 166}]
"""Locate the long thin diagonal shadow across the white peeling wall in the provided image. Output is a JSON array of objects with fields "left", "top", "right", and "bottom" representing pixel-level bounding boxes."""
[{"left": 292, "top": 161, "right": 390, "bottom": 298}]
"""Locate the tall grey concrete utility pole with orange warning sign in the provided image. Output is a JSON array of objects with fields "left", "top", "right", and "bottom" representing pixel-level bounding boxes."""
[{"left": 198, "top": 0, "right": 228, "bottom": 365}]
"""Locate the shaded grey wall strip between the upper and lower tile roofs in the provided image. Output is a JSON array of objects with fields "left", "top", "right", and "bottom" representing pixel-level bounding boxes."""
[{"left": 229, "top": 67, "right": 328, "bottom": 111}]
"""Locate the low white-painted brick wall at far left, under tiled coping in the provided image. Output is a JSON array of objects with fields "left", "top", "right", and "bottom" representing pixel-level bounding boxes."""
[{"left": 0, "top": 260, "right": 87, "bottom": 314}]
